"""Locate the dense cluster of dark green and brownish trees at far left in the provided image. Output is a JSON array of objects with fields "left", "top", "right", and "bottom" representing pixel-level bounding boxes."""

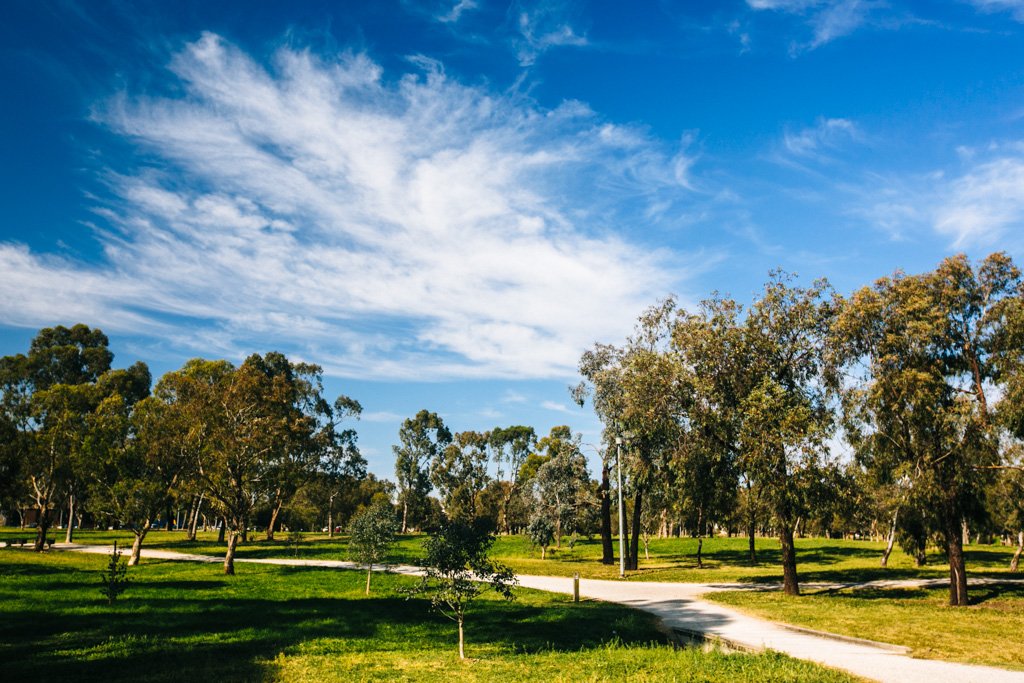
[{"left": 0, "top": 325, "right": 374, "bottom": 573}]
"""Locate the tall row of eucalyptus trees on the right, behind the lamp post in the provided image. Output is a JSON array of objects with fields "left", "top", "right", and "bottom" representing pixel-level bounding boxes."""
[{"left": 573, "top": 253, "right": 1024, "bottom": 605}]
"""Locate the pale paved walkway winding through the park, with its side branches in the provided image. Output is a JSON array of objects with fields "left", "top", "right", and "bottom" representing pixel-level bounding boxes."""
[{"left": 54, "top": 544, "right": 1024, "bottom": 683}]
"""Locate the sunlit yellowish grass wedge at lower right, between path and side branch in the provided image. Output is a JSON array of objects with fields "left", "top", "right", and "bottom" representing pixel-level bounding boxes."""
[{"left": 707, "top": 586, "right": 1024, "bottom": 670}]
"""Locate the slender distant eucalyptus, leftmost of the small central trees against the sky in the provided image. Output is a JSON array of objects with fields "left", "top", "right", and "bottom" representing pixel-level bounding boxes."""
[{"left": 391, "top": 410, "right": 452, "bottom": 533}]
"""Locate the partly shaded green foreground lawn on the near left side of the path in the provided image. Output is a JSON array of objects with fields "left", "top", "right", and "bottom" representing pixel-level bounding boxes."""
[{"left": 0, "top": 539, "right": 851, "bottom": 681}]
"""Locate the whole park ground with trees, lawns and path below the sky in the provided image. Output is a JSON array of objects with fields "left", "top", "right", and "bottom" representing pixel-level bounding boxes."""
[{"left": 0, "top": 253, "right": 1024, "bottom": 681}]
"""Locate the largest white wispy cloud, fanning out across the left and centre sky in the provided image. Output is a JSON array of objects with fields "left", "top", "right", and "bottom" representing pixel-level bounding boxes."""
[{"left": 0, "top": 35, "right": 690, "bottom": 378}]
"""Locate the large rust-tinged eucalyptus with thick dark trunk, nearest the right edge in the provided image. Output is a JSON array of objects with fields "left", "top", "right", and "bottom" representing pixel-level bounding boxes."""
[{"left": 837, "top": 254, "right": 1021, "bottom": 605}]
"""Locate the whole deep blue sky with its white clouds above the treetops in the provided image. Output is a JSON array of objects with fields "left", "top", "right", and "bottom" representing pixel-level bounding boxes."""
[{"left": 0, "top": 0, "right": 1024, "bottom": 475}]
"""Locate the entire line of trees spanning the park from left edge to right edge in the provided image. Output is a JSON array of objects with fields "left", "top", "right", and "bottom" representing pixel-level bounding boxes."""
[{"left": 0, "top": 253, "right": 1024, "bottom": 605}]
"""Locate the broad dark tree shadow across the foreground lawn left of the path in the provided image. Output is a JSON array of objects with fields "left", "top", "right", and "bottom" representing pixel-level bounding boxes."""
[{"left": 0, "top": 565, "right": 654, "bottom": 681}]
